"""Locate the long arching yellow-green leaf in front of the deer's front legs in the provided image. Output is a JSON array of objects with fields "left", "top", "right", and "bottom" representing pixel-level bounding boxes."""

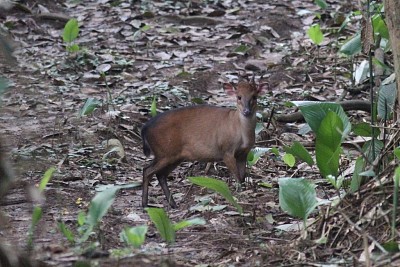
[{"left": 188, "top": 177, "right": 243, "bottom": 214}]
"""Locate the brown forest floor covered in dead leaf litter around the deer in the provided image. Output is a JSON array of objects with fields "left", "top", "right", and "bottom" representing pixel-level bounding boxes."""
[{"left": 0, "top": 0, "right": 388, "bottom": 266}]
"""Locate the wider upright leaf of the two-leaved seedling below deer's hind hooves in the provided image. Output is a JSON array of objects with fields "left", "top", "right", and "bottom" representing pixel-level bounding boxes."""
[{"left": 145, "top": 208, "right": 175, "bottom": 244}]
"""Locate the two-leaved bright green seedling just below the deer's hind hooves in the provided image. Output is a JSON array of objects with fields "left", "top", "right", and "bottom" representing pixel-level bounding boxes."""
[{"left": 146, "top": 208, "right": 206, "bottom": 244}]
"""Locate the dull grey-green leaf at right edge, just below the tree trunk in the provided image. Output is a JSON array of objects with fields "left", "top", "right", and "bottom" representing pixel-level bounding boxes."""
[{"left": 378, "top": 82, "right": 397, "bottom": 120}]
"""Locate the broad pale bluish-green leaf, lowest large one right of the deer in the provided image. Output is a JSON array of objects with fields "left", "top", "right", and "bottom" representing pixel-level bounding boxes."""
[{"left": 278, "top": 178, "right": 318, "bottom": 221}]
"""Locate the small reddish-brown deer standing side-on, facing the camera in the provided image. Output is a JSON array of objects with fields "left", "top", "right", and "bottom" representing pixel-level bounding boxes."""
[{"left": 141, "top": 76, "right": 267, "bottom": 208}]
